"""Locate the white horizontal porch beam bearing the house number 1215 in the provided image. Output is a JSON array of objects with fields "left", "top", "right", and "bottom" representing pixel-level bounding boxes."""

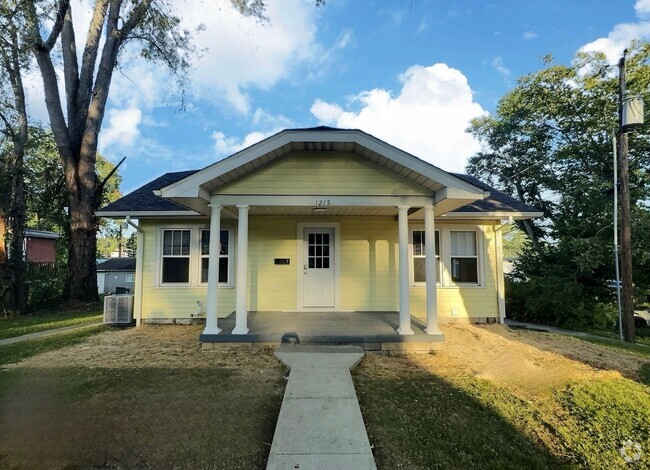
[{"left": 212, "top": 194, "right": 433, "bottom": 208}]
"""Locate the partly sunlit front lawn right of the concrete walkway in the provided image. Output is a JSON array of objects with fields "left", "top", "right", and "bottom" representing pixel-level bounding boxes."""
[{"left": 353, "top": 326, "right": 650, "bottom": 469}]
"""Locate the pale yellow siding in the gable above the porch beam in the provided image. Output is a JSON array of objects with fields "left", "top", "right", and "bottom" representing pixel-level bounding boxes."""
[{"left": 215, "top": 152, "right": 431, "bottom": 196}]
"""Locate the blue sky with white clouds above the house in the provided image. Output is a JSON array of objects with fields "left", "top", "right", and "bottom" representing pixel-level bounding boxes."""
[{"left": 27, "top": 0, "right": 650, "bottom": 193}]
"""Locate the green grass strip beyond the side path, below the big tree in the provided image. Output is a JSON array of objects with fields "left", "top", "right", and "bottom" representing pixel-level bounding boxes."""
[{"left": 0, "top": 304, "right": 102, "bottom": 339}]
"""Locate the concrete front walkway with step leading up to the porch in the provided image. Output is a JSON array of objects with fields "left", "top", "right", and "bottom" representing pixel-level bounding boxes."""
[{"left": 266, "top": 345, "right": 376, "bottom": 470}]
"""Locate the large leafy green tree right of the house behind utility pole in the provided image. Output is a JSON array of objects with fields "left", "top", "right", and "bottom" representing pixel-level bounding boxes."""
[{"left": 468, "top": 43, "right": 650, "bottom": 338}]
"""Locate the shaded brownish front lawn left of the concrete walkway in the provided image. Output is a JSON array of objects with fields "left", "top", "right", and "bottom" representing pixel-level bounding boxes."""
[{"left": 0, "top": 325, "right": 286, "bottom": 469}]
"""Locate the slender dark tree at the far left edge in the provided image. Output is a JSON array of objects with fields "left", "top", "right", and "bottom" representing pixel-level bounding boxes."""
[{"left": 0, "top": 0, "right": 29, "bottom": 315}]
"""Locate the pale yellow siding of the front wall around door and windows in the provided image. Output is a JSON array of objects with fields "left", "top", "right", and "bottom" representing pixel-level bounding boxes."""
[{"left": 141, "top": 216, "right": 498, "bottom": 322}]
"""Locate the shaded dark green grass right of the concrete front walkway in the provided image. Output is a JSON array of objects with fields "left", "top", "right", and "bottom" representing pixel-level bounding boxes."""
[{"left": 354, "top": 373, "right": 560, "bottom": 469}]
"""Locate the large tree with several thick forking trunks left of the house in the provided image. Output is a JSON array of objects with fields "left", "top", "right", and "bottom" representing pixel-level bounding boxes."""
[{"left": 21, "top": 0, "right": 300, "bottom": 301}]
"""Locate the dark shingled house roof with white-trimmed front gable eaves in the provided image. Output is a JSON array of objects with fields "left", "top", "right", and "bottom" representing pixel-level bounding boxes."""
[{"left": 97, "top": 126, "right": 542, "bottom": 218}]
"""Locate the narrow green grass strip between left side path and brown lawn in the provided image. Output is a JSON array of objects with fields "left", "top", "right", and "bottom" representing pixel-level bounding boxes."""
[{"left": 0, "top": 325, "right": 108, "bottom": 366}]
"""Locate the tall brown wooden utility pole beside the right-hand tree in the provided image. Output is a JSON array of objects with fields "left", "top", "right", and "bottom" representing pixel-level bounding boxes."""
[{"left": 618, "top": 49, "right": 636, "bottom": 343}]
